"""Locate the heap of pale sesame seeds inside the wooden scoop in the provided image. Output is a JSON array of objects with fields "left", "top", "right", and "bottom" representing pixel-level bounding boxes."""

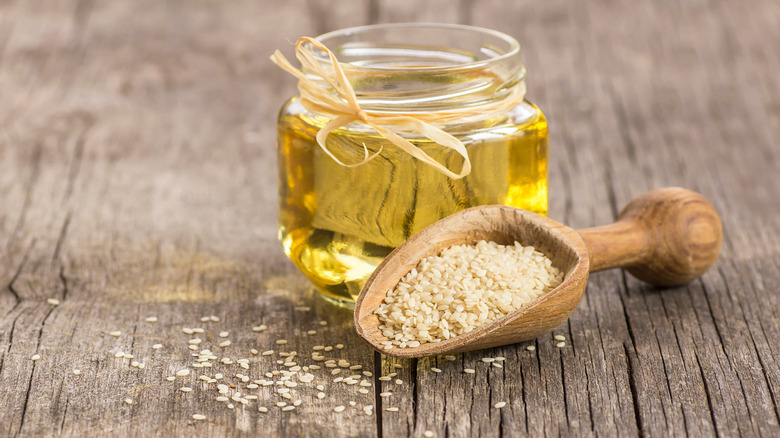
[{"left": 375, "top": 240, "right": 563, "bottom": 350}]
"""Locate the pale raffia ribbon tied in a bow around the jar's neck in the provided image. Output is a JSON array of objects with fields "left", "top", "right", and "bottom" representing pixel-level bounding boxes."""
[{"left": 271, "top": 37, "right": 525, "bottom": 179}]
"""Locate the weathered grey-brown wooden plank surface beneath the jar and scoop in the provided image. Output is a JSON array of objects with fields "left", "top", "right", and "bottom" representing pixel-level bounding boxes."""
[{"left": 0, "top": 0, "right": 780, "bottom": 437}]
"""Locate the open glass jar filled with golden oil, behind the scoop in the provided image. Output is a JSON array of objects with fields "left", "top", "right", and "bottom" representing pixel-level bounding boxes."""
[{"left": 277, "top": 24, "right": 547, "bottom": 304}]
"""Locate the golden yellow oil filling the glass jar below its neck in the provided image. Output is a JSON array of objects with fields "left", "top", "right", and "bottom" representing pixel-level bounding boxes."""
[{"left": 278, "top": 99, "right": 547, "bottom": 303}]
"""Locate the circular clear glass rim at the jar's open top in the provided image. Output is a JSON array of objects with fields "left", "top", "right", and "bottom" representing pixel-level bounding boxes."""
[{"left": 308, "top": 23, "right": 521, "bottom": 72}]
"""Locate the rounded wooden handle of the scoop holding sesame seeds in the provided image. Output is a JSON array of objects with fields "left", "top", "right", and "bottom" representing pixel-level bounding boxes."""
[{"left": 578, "top": 187, "right": 723, "bottom": 286}]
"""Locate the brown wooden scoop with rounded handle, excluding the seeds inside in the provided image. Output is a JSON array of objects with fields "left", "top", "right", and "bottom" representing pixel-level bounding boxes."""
[{"left": 355, "top": 188, "right": 723, "bottom": 357}]
